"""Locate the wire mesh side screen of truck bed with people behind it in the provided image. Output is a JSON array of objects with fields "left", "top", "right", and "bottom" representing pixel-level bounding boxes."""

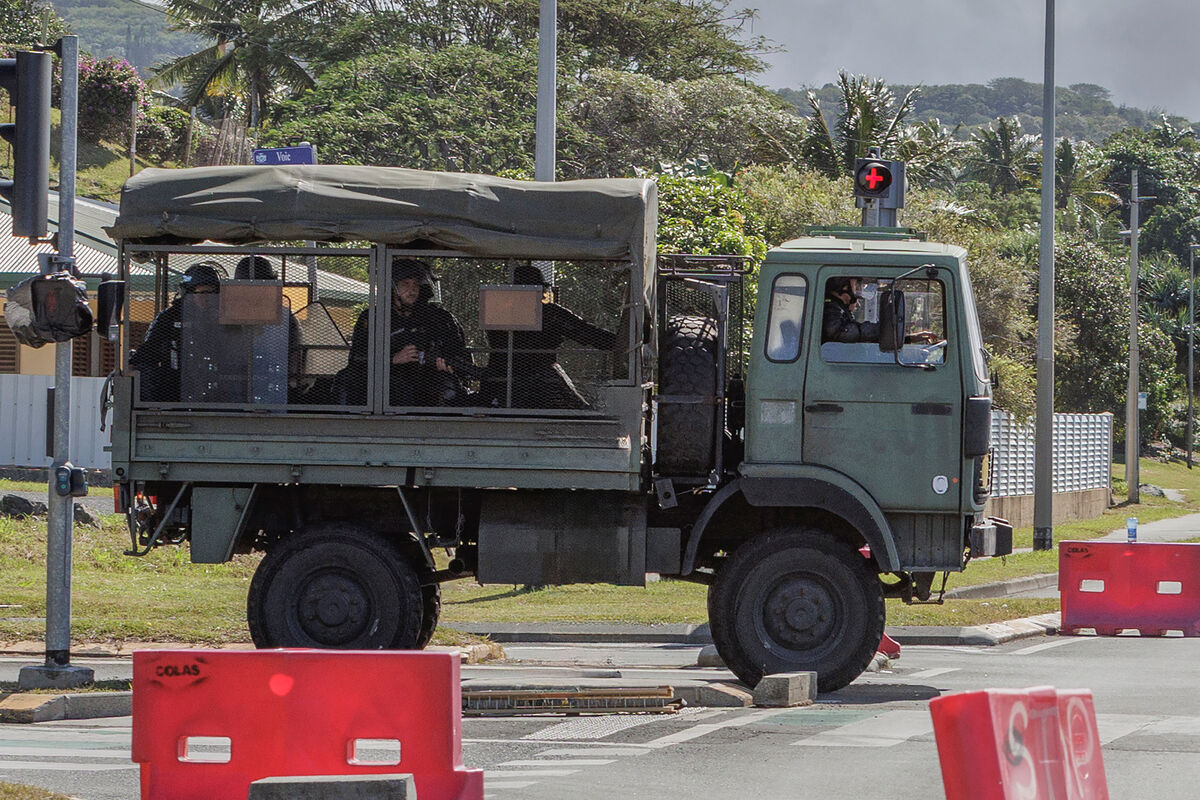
[{"left": 128, "top": 251, "right": 631, "bottom": 413}]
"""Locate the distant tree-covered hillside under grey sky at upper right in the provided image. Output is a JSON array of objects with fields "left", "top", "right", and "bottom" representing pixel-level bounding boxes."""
[{"left": 779, "top": 78, "right": 1184, "bottom": 142}]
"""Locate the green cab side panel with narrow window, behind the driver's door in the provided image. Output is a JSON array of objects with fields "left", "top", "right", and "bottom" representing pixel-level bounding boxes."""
[{"left": 745, "top": 273, "right": 812, "bottom": 464}]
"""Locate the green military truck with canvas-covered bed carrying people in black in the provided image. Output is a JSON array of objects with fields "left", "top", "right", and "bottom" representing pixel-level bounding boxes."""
[{"left": 100, "top": 166, "right": 1010, "bottom": 691}]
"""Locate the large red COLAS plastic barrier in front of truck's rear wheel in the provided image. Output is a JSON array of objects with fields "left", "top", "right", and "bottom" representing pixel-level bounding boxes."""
[{"left": 133, "top": 650, "right": 484, "bottom": 800}]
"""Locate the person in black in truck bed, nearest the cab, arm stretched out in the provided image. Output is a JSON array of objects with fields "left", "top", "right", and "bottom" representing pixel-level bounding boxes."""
[{"left": 481, "top": 264, "right": 617, "bottom": 409}]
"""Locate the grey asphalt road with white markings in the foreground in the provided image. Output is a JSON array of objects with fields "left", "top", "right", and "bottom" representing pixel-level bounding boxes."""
[{"left": 0, "top": 637, "right": 1200, "bottom": 800}]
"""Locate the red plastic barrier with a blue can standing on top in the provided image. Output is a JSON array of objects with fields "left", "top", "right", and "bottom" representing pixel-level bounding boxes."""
[{"left": 1058, "top": 542, "right": 1200, "bottom": 636}]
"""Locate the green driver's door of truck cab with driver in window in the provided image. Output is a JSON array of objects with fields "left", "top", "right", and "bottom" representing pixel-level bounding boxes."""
[{"left": 803, "top": 266, "right": 962, "bottom": 512}]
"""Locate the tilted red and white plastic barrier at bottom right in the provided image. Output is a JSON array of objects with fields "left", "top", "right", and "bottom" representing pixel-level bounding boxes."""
[{"left": 929, "top": 686, "right": 1109, "bottom": 800}]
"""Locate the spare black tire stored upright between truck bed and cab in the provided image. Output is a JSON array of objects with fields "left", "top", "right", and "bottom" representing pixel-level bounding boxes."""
[{"left": 656, "top": 314, "right": 718, "bottom": 476}]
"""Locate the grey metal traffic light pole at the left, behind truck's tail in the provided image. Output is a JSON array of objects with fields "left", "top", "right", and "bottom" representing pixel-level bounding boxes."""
[{"left": 18, "top": 36, "right": 95, "bottom": 690}]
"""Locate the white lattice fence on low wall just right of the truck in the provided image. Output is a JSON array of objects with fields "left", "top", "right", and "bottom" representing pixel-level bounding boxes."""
[{"left": 991, "top": 411, "right": 1112, "bottom": 498}]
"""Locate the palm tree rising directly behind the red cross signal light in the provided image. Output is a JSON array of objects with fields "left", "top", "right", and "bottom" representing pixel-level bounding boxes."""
[{"left": 802, "top": 72, "right": 918, "bottom": 178}]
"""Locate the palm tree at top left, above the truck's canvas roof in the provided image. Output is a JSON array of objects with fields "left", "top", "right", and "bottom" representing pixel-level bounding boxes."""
[{"left": 155, "top": 0, "right": 337, "bottom": 128}]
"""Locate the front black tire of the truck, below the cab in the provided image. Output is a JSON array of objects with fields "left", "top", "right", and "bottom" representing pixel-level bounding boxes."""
[{"left": 708, "top": 528, "right": 884, "bottom": 692}]
